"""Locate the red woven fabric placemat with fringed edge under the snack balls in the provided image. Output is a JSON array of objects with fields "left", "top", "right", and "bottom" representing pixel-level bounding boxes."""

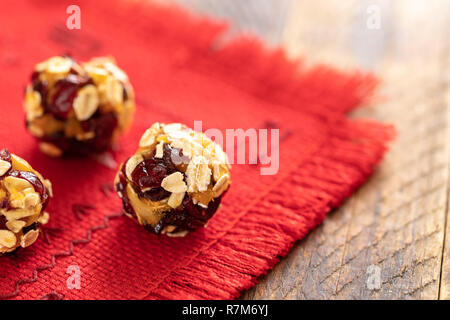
[{"left": 0, "top": 0, "right": 393, "bottom": 299}]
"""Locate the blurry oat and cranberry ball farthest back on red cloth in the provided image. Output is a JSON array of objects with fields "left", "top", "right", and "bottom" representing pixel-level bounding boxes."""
[{"left": 24, "top": 56, "right": 135, "bottom": 157}]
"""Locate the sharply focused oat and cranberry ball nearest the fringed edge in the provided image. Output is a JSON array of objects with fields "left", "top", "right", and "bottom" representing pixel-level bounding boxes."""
[{"left": 115, "top": 123, "right": 230, "bottom": 236}]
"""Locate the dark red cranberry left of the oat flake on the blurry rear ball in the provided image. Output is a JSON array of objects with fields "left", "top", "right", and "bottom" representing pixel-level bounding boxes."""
[{"left": 47, "top": 74, "right": 92, "bottom": 120}]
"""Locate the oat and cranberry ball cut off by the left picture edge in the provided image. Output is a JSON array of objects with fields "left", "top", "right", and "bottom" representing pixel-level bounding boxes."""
[{"left": 0, "top": 149, "right": 52, "bottom": 255}]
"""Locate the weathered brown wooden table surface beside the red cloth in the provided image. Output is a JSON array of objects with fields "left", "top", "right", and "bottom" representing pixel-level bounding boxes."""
[{"left": 171, "top": 0, "right": 450, "bottom": 299}]
